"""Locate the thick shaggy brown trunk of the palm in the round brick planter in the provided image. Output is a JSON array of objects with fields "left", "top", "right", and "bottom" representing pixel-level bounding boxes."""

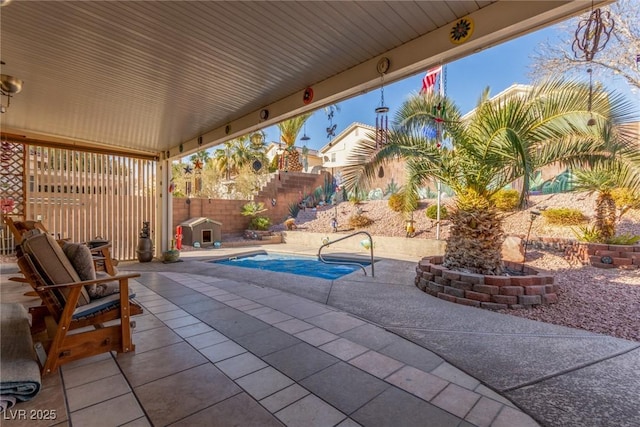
[{"left": 444, "top": 206, "right": 504, "bottom": 275}]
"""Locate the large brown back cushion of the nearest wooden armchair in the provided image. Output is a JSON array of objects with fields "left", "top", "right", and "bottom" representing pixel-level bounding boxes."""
[{"left": 21, "top": 233, "right": 90, "bottom": 306}]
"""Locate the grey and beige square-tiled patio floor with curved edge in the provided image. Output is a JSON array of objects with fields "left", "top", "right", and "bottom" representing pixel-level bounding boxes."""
[{"left": 1, "top": 266, "right": 538, "bottom": 427}]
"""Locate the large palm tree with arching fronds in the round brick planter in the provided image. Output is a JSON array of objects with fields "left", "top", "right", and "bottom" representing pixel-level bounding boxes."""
[{"left": 344, "top": 80, "right": 640, "bottom": 275}]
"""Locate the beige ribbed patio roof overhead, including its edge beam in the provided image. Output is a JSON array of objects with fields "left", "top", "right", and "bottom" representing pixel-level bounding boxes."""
[{"left": 0, "top": 0, "right": 608, "bottom": 159}]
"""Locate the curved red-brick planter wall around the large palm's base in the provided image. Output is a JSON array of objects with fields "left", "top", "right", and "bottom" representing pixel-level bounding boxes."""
[{"left": 415, "top": 256, "right": 558, "bottom": 310}]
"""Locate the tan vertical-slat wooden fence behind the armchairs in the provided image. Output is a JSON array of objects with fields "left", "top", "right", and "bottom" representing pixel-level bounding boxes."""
[{"left": 5, "top": 146, "right": 156, "bottom": 260}]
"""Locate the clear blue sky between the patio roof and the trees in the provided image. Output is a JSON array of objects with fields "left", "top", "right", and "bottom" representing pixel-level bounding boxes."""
[{"left": 264, "top": 23, "right": 630, "bottom": 149}]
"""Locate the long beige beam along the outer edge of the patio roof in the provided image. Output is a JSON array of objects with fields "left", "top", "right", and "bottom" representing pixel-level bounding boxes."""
[{"left": 172, "top": 0, "right": 613, "bottom": 158}]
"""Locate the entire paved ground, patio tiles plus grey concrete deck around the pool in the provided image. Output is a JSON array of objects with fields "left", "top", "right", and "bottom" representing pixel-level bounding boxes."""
[{"left": 2, "top": 244, "right": 640, "bottom": 427}]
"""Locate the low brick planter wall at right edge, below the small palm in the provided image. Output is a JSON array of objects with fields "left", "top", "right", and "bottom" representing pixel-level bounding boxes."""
[{"left": 565, "top": 243, "right": 640, "bottom": 270}]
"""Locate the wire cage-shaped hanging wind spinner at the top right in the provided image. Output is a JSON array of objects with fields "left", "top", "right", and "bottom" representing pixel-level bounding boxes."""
[{"left": 571, "top": 0, "right": 615, "bottom": 126}]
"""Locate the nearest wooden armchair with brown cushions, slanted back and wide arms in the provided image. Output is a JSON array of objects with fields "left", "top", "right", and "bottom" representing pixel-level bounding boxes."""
[{"left": 18, "top": 234, "right": 142, "bottom": 376}]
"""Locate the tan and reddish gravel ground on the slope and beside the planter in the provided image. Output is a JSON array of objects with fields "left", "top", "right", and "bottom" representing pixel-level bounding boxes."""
[{"left": 276, "top": 193, "right": 640, "bottom": 342}]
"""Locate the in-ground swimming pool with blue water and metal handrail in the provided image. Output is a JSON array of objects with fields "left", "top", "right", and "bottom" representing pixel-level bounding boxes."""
[{"left": 209, "top": 253, "right": 371, "bottom": 280}]
